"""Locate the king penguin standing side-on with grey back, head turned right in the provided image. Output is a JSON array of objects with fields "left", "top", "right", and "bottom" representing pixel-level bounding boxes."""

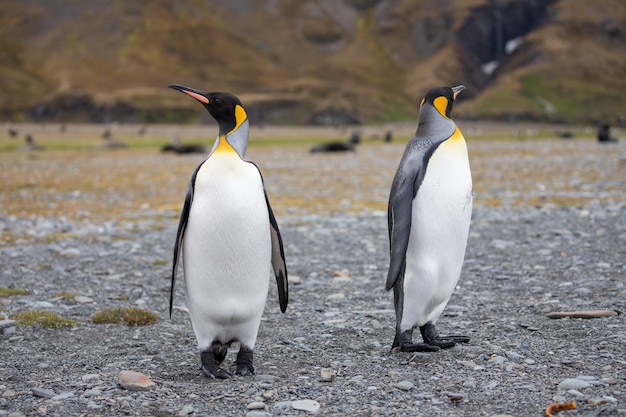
[{"left": 385, "top": 85, "right": 472, "bottom": 352}]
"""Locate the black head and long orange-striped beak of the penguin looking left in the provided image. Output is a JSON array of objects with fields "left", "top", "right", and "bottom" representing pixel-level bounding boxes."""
[{"left": 168, "top": 84, "right": 247, "bottom": 135}]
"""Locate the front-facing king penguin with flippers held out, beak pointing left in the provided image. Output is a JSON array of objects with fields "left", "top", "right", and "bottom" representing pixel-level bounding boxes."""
[{"left": 169, "top": 84, "right": 288, "bottom": 379}]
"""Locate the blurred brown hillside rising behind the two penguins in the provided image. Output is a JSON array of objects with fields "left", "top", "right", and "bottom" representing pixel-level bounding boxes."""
[{"left": 0, "top": 0, "right": 626, "bottom": 124}]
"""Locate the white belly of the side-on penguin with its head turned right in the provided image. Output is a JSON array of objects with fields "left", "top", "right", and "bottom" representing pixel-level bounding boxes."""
[{"left": 401, "top": 138, "right": 472, "bottom": 331}]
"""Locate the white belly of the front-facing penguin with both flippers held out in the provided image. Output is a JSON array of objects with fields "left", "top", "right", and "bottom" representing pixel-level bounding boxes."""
[{"left": 183, "top": 155, "right": 271, "bottom": 350}]
